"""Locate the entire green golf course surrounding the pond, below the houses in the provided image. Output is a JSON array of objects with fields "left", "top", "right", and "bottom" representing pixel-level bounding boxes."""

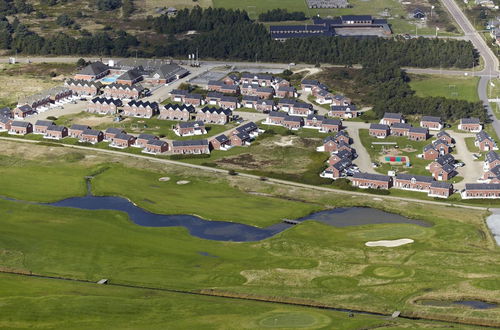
[{"left": 0, "top": 141, "right": 500, "bottom": 329}]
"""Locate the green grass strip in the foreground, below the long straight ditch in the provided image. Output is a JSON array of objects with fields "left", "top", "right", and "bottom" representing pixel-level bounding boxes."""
[{"left": 0, "top": 274, "right": 480, "bottom": 329}]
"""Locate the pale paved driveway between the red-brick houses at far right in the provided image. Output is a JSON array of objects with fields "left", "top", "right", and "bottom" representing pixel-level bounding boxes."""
[{"left": 447, "top": 130, "right": 483, "bottom": 189}]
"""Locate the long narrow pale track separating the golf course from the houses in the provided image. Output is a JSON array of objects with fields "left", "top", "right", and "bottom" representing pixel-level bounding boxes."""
[{"left": 0, "top": 137, "right": 488, "bottom": 210}]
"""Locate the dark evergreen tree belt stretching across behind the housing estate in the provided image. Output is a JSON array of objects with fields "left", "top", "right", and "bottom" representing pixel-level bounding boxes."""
[{"left": 0, "top": 5, "right": 478, "bottom": 68}]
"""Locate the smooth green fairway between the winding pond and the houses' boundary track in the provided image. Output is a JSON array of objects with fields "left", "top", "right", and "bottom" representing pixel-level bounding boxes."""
[{"left": 93, "top": 166, "right": 321, "bottom": 227}]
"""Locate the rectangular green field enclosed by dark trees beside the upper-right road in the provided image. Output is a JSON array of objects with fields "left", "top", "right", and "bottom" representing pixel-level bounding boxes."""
[{"left": 410, "top": 74, "right": 479, "bottom": 102}]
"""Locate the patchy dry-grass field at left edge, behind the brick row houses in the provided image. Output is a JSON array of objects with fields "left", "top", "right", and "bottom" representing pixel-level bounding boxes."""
[{"left": 0, "top": 63, "right": 75, "bottom": 107}]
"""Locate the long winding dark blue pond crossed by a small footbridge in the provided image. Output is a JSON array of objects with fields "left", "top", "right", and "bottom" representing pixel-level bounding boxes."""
[{"left": 43, "top": 195, "right": 430, "bottom": 242}]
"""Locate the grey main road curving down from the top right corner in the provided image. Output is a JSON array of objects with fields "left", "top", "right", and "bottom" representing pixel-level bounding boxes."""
[{"left": 442, "top": 0, "right": 500, "bottom": 135}]
